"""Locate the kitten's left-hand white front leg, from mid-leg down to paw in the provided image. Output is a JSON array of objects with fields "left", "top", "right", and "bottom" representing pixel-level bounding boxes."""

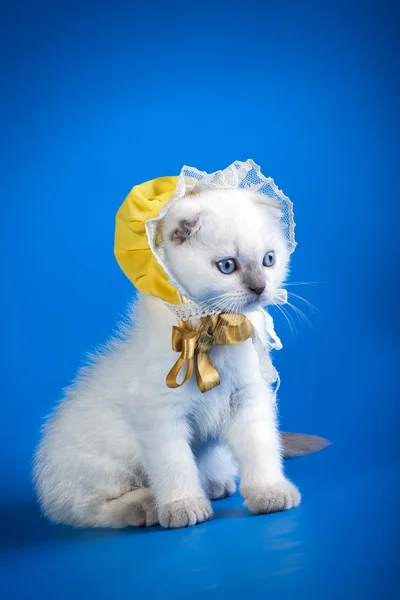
[{"left": 141, "top": 413, "right": 212, "bottom": 527}]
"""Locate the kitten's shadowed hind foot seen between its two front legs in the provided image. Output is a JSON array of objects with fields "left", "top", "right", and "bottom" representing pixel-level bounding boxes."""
[{"left": 198, "top": 442, "right": 238, "bottom": 500}]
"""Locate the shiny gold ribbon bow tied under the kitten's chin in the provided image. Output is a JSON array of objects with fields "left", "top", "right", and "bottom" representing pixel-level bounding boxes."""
[{"left": 166, "top": 314, "right": 251, "bottom": 393}]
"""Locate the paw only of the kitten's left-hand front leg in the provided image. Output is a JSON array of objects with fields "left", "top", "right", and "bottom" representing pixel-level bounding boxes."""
[{"left": 158, "top": 497, "right": 212, "bottom": 527}]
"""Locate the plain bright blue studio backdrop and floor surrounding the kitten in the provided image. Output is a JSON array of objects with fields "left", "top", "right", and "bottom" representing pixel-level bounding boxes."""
[{"left": 0, "top": 0, "right": 399, "bottom": 599}]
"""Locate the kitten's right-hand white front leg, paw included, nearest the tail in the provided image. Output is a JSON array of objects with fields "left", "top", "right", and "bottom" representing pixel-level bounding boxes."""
[{"left": 227, "top": 382, "right": 300, "bottom": 513}]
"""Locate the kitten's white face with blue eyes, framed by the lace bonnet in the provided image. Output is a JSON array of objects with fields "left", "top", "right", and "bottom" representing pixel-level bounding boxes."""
[{"left": 163, "top": 189, "right": 289, "bottom": 312}]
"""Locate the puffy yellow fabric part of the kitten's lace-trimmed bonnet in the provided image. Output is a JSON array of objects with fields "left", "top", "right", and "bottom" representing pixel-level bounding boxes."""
[{"left": 114, "top": 176, "right": 181, "bottom": 304}]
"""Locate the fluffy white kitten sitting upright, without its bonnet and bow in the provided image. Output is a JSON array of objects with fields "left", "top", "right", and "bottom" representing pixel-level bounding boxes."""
[{"left": 35, "top": 189, "right": 300, "bottom": 527}]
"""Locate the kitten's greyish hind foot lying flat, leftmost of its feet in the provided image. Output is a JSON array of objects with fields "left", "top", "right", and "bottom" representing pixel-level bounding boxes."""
[{"left": 95, "top": 488, "right": 158, "bottom": 527}]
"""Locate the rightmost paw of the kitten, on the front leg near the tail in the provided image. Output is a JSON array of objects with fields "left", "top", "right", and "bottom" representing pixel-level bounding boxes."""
[{"left": 242, "top": 479, "right": 301, "bottom": 515}]
